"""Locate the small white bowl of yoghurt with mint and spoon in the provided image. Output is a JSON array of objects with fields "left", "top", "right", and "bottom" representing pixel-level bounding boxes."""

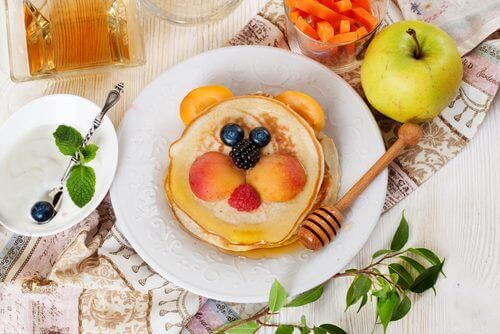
[{"left": 0, "top": 95, "right": 118, "bottom": 237}]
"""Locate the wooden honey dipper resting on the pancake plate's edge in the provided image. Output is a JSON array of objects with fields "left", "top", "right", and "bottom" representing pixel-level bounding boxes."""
[{"left": 298, "top": 123, "right": 422, "bottom": 250}]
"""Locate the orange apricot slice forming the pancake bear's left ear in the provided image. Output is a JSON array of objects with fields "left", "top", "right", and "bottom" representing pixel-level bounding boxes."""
[{"left": 180, "top": 85, "right": 233, "bottom": 125}]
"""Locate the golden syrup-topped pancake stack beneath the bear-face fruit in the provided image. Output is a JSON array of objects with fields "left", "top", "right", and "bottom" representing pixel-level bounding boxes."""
[{"left": 165, "top": 96, "right": 332, "bottom": 251}]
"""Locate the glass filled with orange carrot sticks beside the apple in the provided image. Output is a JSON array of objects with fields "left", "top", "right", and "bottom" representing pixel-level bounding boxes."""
[{"left": 284, "top": 0, "right": 388, "bottom": 73}]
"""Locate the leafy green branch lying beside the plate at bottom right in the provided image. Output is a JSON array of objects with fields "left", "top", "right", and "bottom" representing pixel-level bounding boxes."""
[{"left": 217, "top": 213, "right": 444, "bottom": 334}]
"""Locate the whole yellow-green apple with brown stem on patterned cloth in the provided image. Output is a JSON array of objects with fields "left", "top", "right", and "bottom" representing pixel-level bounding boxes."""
[{"left": 361, "top": 21, "right": 463, "bottom": 122}]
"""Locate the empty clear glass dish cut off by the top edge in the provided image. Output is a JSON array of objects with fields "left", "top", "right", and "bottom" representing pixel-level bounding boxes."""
[{"left": 142, "top": 0, "right": 241, "bottom": 24}]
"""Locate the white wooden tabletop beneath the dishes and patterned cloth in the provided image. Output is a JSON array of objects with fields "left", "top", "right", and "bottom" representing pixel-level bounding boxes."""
[{"left": 0, "top": 0, "right": 500, "bottom": 334}]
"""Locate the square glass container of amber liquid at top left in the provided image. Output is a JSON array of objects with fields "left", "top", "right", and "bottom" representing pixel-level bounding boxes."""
[{"left": 2, "top": 0, "right": 145, "bottom": 81}]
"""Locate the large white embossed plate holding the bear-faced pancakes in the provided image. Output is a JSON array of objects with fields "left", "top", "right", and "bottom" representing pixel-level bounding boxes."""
[{"left": 111, "top": 46, "right": 387, "bottom": 303}]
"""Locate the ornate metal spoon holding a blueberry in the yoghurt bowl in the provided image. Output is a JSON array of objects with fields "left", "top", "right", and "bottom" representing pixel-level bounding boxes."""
[{"left": 31, "top": 82, "right": 125, "bottom": 224}]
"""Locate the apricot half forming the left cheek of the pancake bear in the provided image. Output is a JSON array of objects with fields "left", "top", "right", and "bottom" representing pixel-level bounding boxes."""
[{"left": 189, "top": 152, "right": 245, "bottom": 202}]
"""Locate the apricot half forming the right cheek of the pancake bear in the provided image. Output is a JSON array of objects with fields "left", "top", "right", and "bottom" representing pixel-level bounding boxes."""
[{"left": 247, "top": 154, "right": 307, "bottom": 202}]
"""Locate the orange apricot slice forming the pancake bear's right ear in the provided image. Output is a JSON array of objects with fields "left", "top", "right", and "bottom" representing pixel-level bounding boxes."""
[{"left": 276, "top": 90, "right": 325, "bottom": 133}]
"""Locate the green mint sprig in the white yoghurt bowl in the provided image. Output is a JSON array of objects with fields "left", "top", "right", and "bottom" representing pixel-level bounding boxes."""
[{"left": 52, "top": 125, "right": 99, "bottom": 208}]
